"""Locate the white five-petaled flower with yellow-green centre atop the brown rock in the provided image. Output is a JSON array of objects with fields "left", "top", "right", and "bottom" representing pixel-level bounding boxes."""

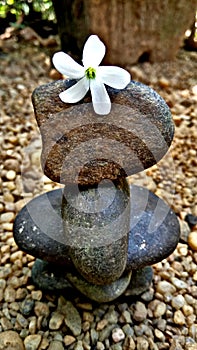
[{"left": 53, "top": 35, "right": 130, "bottom": 115}]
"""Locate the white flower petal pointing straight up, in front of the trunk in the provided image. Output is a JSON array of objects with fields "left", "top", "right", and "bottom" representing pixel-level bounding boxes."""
[{"left": 82, "top": 35, "right": 105, "bottom": 69}]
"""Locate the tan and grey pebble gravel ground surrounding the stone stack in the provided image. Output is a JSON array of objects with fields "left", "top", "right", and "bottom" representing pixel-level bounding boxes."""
[{"left": 0, "top": 38, "right": 197, "bottom": 350}]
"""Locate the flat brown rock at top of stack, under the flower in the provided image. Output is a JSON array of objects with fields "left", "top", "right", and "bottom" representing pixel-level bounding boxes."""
[{"left": 32, "top": 80, "right": 174, "bottom": 186}]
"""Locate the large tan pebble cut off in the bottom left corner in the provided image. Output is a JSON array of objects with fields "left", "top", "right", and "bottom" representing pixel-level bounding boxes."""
[{"left": 0, "top": 331, "right": 25, "bottom": 350}]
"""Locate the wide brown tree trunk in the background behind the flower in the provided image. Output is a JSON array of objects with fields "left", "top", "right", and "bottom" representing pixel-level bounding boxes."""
[{"left": 53, "top": 0, "right": 196, "bottom": 66}]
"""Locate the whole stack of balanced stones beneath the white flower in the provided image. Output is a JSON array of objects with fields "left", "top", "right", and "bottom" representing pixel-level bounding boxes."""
[{"left": 14, "top": 80, "right": 180, "bottom": 302}]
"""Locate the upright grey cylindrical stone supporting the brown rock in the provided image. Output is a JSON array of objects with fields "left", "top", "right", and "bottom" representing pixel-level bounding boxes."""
[{"left": 62, "top": 179, "right": 130, "bottom": 285}]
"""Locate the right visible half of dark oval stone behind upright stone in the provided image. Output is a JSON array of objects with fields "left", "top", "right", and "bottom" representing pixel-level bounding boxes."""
[{"left": 127, "top": 185, "right": 180, "bottom": 270}]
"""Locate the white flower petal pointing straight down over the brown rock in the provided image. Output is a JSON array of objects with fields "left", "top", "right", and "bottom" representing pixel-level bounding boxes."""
[{"left": 90, "top": 79, "right": 111, "bottom": 115}]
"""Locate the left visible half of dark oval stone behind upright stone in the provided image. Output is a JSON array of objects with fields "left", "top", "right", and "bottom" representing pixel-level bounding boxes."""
[{"left": 13, "top": 189, "right": 71, "bottom": 267}]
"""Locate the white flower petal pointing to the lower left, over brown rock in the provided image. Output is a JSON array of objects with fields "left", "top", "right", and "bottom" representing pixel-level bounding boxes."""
[{"left": 59, "top": 77, "right": 89, "bottom": 103}]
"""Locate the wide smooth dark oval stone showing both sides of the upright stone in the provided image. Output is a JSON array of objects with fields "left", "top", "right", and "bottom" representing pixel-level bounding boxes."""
[{"left": 14, "top": 186, "right": 180, "bottom": 271}]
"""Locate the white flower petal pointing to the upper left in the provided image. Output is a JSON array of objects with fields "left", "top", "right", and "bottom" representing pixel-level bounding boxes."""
[{"left": 52, "top": 51, "right": 85, "bottom": 79}]
